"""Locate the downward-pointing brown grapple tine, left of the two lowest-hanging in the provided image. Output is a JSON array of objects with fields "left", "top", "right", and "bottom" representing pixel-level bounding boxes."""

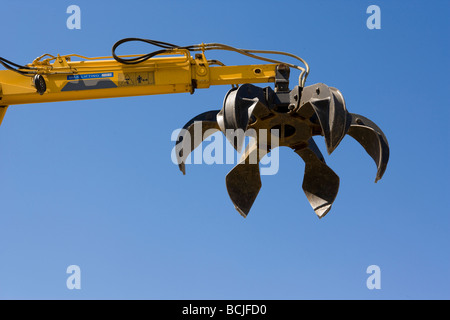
[{"left": 225, "top": 141, "right": 266, "bottom": 218}]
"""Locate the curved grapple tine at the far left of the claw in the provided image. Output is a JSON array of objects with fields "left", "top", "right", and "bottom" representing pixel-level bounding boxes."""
[{"left": 175, "top": 110, "right": 220, "bottom": 174}]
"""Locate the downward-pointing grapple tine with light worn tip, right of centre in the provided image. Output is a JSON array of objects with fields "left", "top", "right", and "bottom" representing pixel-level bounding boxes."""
[{"left": 294, "top": 138, "right": 339, "bottom": 218}]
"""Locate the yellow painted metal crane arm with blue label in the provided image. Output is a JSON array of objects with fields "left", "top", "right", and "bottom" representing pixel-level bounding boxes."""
[{"left": 0, "top": 49, "right": 277, "bottom": 107}]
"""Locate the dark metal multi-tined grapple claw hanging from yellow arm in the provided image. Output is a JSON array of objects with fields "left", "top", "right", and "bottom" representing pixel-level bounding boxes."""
[{"left": 177, "top": 83, "right": 389, "bottom": 218}]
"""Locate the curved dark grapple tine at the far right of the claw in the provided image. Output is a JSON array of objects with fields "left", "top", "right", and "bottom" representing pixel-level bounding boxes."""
[{"left": 348, "top": 113, "right": 389, "bottom": 182}]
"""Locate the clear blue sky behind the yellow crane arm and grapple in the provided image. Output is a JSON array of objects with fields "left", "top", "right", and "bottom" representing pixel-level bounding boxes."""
[{"left": 0, "top": 0, "right": 450, "bottom": 299}]
